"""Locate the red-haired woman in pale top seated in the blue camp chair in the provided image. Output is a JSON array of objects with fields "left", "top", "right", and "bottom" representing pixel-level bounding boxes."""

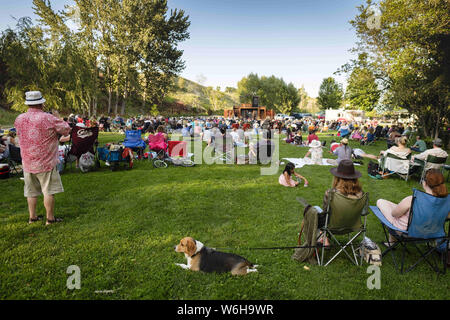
[{"left": 377, "top": 169, "right": 450, "bottom": 247}]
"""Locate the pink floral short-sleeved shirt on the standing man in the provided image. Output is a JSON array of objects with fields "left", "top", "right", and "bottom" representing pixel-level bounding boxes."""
[{"left": 14, "top": 108, "right": 71, "bottom": 173}]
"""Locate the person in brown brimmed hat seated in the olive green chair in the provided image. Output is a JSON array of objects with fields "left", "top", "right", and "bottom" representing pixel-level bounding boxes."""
[{"left": 316, "top": 159, "right": 364, "bottom": 246}]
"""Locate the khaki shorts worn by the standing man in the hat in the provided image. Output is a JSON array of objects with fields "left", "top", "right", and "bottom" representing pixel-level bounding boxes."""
[{"left": 23, "top": 167, "right": 64, "bottom": 198}]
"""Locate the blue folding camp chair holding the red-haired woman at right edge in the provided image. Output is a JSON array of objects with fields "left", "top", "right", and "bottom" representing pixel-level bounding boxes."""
[{"left": 370, "top": 189, "right": 450, "bottom": 273}]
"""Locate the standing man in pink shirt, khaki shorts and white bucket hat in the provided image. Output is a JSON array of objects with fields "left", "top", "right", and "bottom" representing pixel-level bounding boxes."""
[{"left": 14, "top": 91, "right": 70, "bottom": 225}]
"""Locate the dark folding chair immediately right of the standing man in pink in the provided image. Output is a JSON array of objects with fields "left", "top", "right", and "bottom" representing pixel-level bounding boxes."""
[{"left": 64, "top": 126, "right": 100, "bottom": 168}]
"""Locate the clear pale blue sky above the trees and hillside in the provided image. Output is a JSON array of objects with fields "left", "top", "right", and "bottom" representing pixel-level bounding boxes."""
[{"left": 0, "top": 0, "right": 364, "bottom": 97}]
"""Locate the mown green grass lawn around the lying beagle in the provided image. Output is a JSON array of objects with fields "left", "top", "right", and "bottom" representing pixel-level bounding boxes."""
[{"left": 0, "top": 134, "right": 450, "bottom": 300}]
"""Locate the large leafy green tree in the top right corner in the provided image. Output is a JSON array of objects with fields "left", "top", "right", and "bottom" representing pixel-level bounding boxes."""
[{"left": 350, "top": 0, "right": 450, "bottom": 137}]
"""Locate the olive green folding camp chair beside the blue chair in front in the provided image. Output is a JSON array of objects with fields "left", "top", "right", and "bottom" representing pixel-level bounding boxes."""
[{"left": 315, "top": 191, "right": 369, "bottom": 266}]
